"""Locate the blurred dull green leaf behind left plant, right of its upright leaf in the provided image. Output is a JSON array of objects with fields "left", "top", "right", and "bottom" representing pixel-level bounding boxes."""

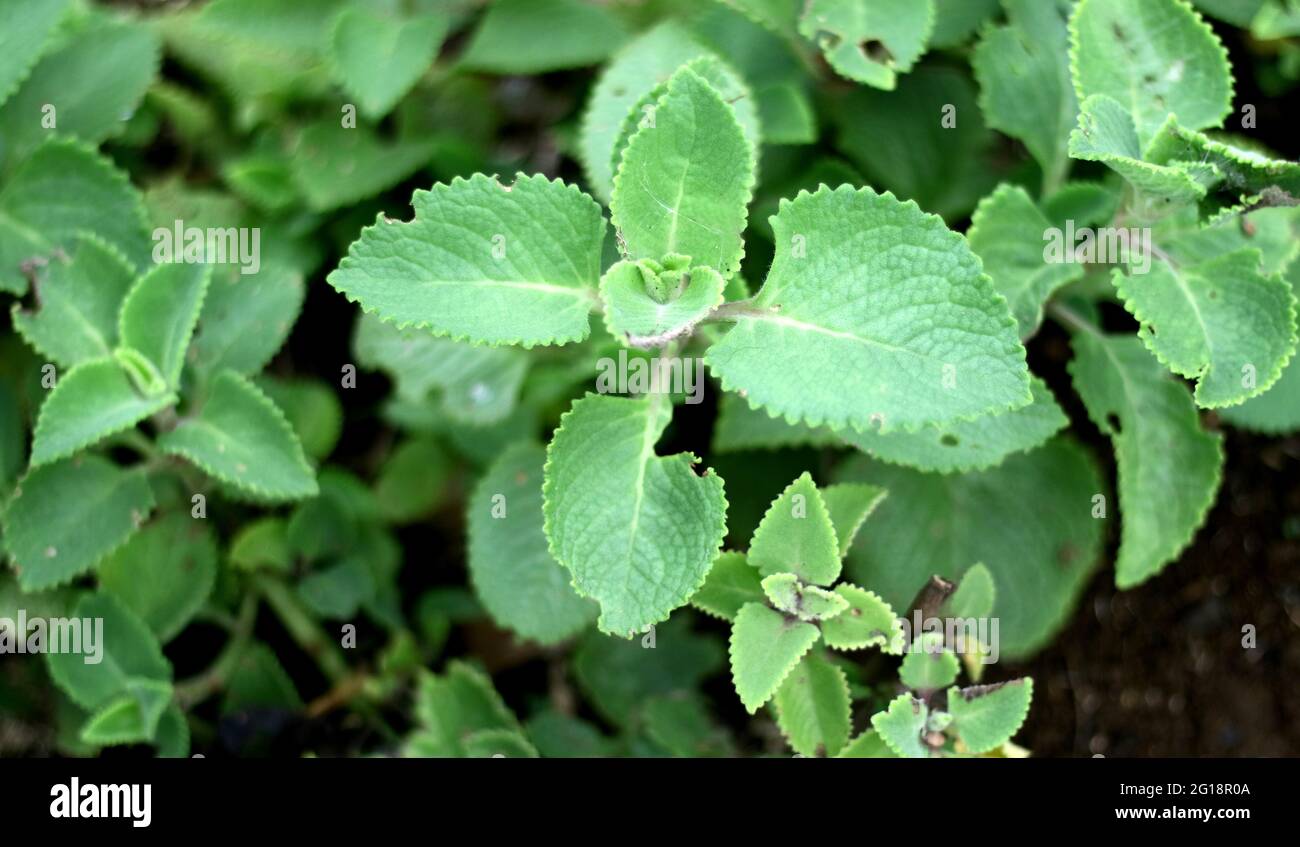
[{"left": 194, "top": 265, "right": 306, "bottom": 375}]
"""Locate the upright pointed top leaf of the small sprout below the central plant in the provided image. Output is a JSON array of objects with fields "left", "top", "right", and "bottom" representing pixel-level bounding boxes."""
[{"left": 749, "top": 473, "right": 840, "bottom": 585}]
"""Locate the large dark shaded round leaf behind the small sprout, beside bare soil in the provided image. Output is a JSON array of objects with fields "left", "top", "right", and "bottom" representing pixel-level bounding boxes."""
[{"left": 841, "top": 438, "right": 1104, "bottom": 657}]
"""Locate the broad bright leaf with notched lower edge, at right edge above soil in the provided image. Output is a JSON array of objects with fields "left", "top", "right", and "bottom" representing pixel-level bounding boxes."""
[{"left": 1112, "top": 248, "right": 1296, "bottom": 409}]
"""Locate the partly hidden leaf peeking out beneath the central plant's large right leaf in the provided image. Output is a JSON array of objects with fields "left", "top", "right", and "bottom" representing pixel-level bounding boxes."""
[{"left": 841, "top": 377, "right": 1070, "bottom": 473}]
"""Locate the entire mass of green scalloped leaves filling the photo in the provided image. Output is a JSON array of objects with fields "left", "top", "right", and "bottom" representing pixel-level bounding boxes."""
[{"left": 0, "top": 0, "right": 1300, "bottom": 756}]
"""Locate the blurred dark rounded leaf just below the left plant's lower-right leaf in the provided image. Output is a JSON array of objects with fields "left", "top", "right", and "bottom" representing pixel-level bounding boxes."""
[{"left": 98, "top": 512, "right": 217, "bottom": 643}]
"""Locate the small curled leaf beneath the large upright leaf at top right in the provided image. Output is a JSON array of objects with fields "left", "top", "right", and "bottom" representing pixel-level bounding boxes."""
[{"left": 1070, "top": 94, "right": 1201, "bottom": 203}]
